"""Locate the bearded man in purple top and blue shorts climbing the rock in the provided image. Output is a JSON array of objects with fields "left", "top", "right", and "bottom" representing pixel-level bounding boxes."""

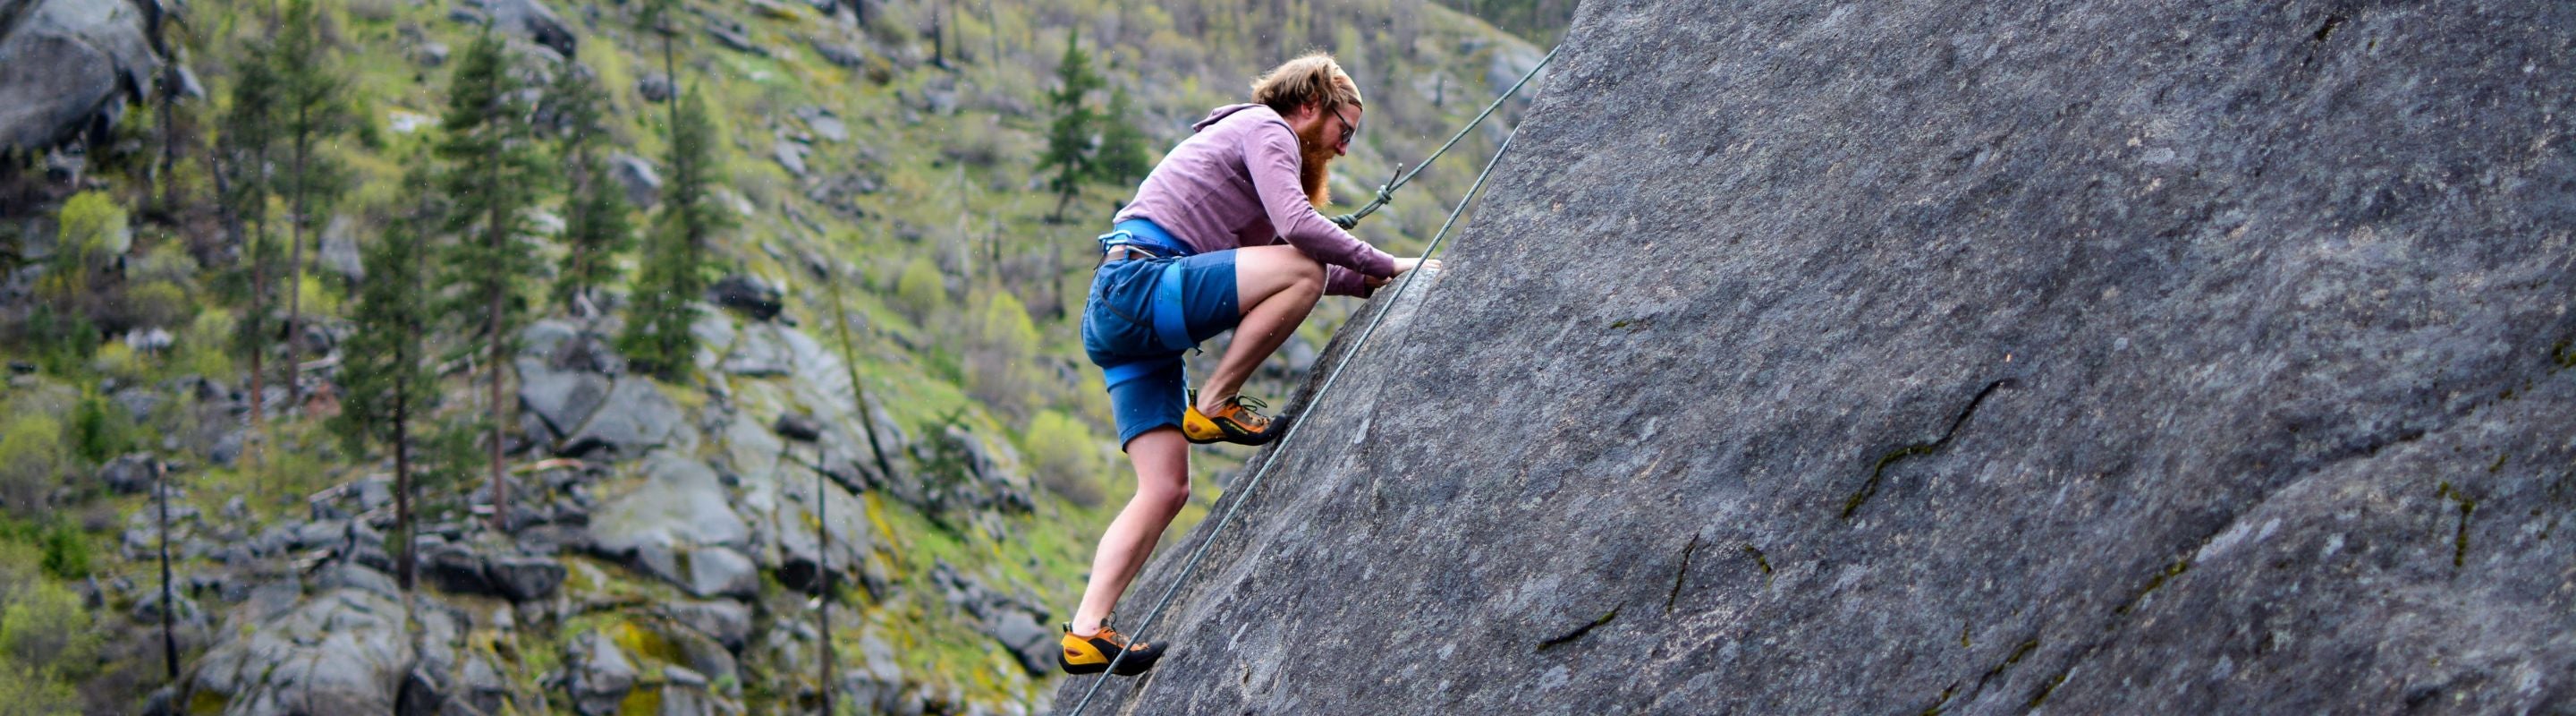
[{"left": 1062, "top": 54, "right": 1440, "bottom": 675}]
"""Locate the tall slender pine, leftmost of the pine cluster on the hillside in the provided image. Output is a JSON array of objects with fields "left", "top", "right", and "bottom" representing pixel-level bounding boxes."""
[{"left": 208, "top": 47, "right": 278, "bottom": 458}]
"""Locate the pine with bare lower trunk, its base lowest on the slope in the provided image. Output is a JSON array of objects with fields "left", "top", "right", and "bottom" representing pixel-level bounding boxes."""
[{"left": 330, "top": 210, "right": 438, "bottom": 590}]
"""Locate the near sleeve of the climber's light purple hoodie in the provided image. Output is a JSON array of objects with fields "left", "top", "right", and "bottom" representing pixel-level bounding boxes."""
[{"left": 1244, "top": 121, "right": 1396, "bottom": 296}]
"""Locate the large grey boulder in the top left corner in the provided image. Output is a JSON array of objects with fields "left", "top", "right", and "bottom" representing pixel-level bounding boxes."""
[{"left": 0, "top": 0, "right": 160, "bottom": 155}]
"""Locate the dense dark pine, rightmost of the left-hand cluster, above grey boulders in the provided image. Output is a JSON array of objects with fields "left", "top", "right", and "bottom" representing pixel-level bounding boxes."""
[{"left": 618, "top": 88, "right": 732, "bottom": 381}]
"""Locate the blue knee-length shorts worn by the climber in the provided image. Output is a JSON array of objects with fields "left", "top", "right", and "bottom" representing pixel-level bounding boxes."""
[{"left": 1082, "top": 250, "right": 1244, "bottom": 451}]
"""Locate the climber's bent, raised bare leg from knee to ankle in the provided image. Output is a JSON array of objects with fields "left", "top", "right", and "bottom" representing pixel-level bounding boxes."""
[{"left": 1198, "top": 247, "right": 1324, "bottom": 412}]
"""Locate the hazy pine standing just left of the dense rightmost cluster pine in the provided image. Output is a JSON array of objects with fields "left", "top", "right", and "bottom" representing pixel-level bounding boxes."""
[{"left": 547, "top": 67, "right": 633, "bottom": 314}]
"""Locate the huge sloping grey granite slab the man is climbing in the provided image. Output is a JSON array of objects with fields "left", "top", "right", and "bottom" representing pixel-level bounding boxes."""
[{"left": 1056, "top": 0, "right": 2576, "bottom": 713}]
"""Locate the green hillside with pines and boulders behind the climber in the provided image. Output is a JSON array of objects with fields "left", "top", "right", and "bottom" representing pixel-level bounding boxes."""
[{"left": 0, "top": 0, "right": 1543, "bottom": 713}]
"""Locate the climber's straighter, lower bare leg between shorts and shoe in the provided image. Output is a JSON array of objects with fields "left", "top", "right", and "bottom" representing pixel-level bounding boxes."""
[{"left": 1072, "top": 428, "right": 1191, "bottom": 636}]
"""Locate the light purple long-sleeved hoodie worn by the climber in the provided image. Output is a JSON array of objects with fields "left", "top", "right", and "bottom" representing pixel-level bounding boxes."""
[{"left": 1115, "top": 106, "right": 1396, "bottom": 296}]
